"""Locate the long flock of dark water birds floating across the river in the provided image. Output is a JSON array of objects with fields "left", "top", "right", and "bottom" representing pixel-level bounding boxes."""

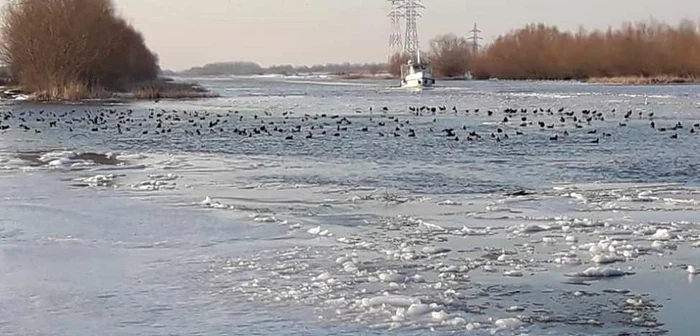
[{"left": 0, "top": 106, "right": 700, "bottom": 143}]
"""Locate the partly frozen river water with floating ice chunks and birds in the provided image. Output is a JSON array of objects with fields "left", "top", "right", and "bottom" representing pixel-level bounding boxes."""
[{"left": 0, "top": 78, "right": 700, "bottom": 335}]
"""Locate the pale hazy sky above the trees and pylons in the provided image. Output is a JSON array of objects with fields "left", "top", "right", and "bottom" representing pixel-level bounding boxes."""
[{"left": 21, "top": 0, "right": 700, "bottom": 70}]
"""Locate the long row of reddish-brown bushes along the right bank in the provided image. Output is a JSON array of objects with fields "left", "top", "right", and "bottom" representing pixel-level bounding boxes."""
[{"left": 470, "top": 21, "right": 700, "bottom": 82}]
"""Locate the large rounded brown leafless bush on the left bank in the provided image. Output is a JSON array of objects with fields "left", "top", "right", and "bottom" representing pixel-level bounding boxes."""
[{"left": 0, "top": 0, "right": 206, "bottom": 100}]
